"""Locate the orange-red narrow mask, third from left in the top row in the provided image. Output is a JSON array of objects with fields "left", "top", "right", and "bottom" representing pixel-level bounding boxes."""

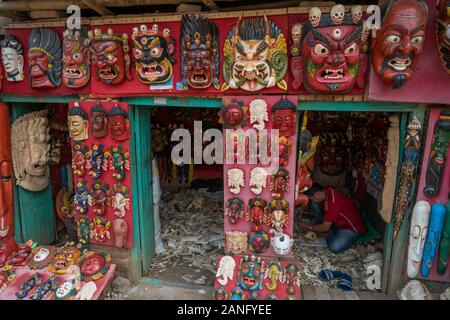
[{"left": 62, "top": 27, "right": 91, "bottom": 88}]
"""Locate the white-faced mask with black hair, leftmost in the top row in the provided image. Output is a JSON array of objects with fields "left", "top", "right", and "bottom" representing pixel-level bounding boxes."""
[{"left": 1, "top": 34, "right": 24, "bottom": 81}]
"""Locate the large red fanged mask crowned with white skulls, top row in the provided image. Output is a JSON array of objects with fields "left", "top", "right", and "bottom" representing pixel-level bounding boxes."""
[{"left": 291, "top": 4, "right": 369, "bottom": 94}]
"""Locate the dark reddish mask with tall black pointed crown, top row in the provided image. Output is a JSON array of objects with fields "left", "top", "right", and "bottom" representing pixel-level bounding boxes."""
[{"left": 181, "top": 14, "right": 220, "bottom": 89}]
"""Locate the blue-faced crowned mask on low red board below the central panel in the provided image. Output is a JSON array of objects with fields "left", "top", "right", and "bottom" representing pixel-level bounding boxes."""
[{"left": 237, "top": 256, "right": 264, "bottom": 291}]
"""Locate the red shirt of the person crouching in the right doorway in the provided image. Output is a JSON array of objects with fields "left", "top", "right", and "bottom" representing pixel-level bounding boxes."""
[{"left": 323, "top": 188, "right": 366, "bottom": 234}]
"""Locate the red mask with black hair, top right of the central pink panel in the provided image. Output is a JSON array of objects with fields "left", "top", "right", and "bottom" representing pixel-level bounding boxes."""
[{"left": 272, "top": 99, "right": 297, "bottom": 137}]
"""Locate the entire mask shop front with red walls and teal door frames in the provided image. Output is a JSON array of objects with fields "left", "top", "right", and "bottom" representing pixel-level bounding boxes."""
[{"left": 0, "top": 0, "right": 450, "bottom": 300}]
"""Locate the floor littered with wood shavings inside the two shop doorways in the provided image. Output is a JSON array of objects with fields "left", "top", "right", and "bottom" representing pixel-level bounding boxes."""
[{"left": 147, "top": 188, "right": 382, "bottom": 290}]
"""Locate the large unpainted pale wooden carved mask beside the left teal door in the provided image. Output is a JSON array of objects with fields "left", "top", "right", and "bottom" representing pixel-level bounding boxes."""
[{"left": 11, "top": 110, "right": 50, "bottom": 191}]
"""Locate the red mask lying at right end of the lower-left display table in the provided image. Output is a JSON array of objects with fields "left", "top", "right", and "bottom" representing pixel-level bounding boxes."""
[{"left": 78, "top": 251, "right": 111, "bottom": 282}]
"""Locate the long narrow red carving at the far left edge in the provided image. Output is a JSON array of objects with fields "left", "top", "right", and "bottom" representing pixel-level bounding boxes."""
[{"left": 0, "top": 102, "right": 14, "bottom": 240}]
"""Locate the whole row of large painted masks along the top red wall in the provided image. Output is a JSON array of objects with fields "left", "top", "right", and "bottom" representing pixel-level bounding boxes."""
[{"left": 1, "top": 0, "right": 450, "bottom": 94}]
